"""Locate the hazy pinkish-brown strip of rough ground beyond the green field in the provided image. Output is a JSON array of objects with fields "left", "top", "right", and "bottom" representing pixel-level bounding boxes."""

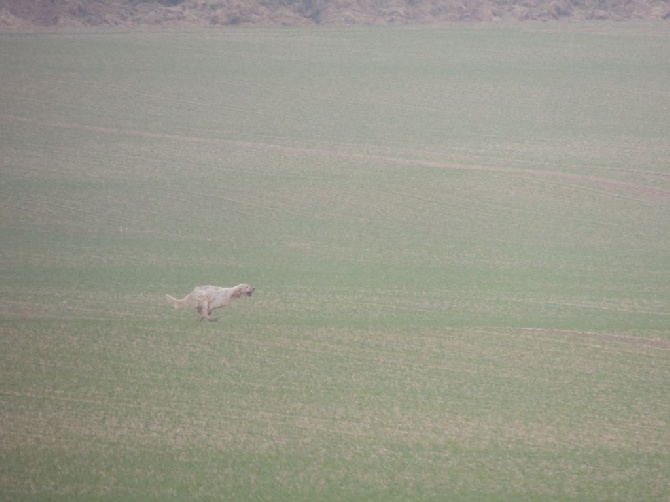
[{"left": 0, "top": 0, "right": 670, "bottom": 29}]
